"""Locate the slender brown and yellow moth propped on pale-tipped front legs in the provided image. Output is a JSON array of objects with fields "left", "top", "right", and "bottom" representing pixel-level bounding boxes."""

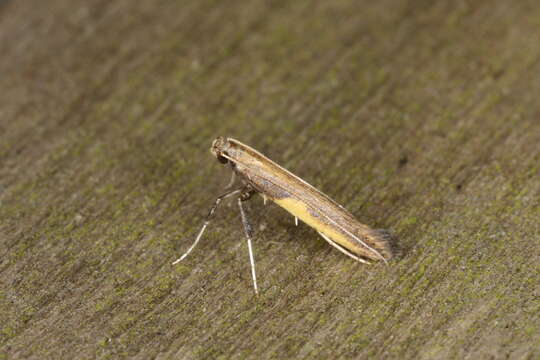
[{"left": 173, "top": 137, "right": 393, "bottom": 294}]
